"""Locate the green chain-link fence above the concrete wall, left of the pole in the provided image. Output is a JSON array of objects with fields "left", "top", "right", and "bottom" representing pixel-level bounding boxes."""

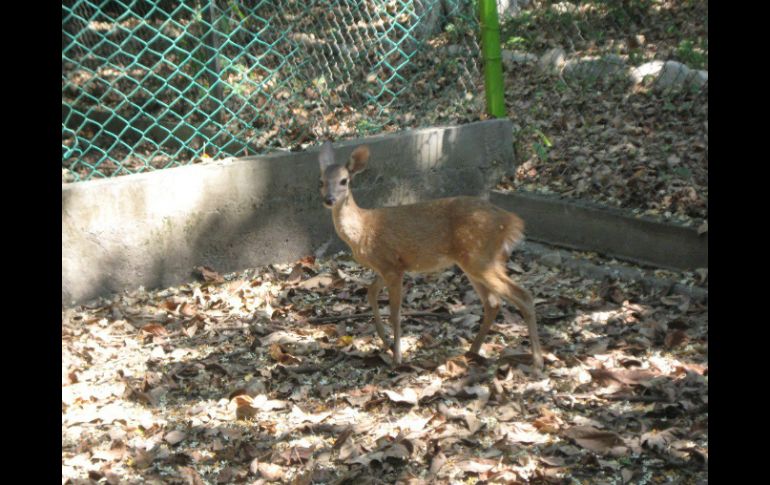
[{"left": 62, "top": 0, "right": 483, "bottom": 180}]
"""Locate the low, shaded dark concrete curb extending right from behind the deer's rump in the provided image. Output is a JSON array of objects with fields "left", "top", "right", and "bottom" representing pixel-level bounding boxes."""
[{"left": 490, "top": 191, "right": 708, "bottom": 270}]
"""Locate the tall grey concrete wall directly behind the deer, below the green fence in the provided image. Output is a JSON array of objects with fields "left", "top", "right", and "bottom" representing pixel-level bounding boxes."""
[{"left": 62, "top": 120, "right": 513, "bottom": 305}]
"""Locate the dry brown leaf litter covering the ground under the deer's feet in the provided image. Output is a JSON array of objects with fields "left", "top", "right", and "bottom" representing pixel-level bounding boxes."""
[{"left": 62, "top": 244, "right": 708, "bottom": 484}]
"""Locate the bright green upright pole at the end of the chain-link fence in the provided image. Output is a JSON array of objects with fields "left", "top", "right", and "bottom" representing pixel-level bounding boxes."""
[{"left": 479, "top": 0, "right": 505, "bottom": 118}]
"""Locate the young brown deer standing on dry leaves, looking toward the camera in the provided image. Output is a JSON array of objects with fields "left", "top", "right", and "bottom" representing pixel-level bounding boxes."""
[{"left": 319, "top": 141, "right": 543, "bottom": 369}]
